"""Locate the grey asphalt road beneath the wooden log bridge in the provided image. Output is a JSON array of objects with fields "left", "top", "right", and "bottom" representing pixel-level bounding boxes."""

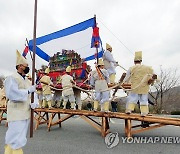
[{"left": 0, "top": 118, "right": 180, "bottom": 154}]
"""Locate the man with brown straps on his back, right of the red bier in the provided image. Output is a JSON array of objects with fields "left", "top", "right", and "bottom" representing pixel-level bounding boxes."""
[{"left": 90, "top": 59, "right": 109, "bottom": 112}]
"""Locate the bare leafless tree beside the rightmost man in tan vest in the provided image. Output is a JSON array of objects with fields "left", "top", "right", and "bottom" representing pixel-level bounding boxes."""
[{"left": 151, "top": 67, "right": 179, "bottom": 113}]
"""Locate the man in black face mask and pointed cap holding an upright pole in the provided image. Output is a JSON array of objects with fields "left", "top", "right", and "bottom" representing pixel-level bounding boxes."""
[{"left": 4, "top": 51, "right": 38, "bottom": 154}]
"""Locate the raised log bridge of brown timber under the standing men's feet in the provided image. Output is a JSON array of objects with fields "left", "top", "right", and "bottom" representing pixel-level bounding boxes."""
[{"left": 0, "top": 107, "right": 180, "bottom": 137}]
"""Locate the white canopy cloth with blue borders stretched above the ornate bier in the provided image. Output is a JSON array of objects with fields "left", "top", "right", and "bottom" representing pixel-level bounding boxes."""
[{"left": 28, "top": 17, "right": 103, "bottom": 62}]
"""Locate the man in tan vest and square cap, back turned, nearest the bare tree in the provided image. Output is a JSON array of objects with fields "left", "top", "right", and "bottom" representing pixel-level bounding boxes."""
[{"left": 124, "top": 51, "right": 154, "bottom": 116}]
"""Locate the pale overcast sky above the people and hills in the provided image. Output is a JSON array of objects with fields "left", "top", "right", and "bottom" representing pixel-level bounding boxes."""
[{"left": 0, "top": 0, "right": 180, "bottom": 78}]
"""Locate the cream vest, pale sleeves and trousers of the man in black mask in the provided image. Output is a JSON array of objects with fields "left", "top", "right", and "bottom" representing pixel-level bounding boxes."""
[{"left": 5, "top": 73, "right": 30, "bottom": 149}]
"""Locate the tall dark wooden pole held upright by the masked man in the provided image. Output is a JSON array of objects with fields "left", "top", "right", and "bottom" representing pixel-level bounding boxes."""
[{"left": 30, "top": 0, "right": 37, "bottom": 137}]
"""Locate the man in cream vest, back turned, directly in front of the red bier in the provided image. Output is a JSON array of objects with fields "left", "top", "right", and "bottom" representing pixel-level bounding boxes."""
[{"left": 61, "top": 66, "right": 76, "bottom": 109}]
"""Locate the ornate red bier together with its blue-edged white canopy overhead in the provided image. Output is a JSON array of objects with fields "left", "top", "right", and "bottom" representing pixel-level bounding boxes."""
[{"left": 28, "top": 17, "right": 104, "bottom": 87}]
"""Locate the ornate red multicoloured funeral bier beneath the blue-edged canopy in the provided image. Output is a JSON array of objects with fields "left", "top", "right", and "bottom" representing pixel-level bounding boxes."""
[{"left": 49, "top": 49, "right": 90, "bottom": 86}]
